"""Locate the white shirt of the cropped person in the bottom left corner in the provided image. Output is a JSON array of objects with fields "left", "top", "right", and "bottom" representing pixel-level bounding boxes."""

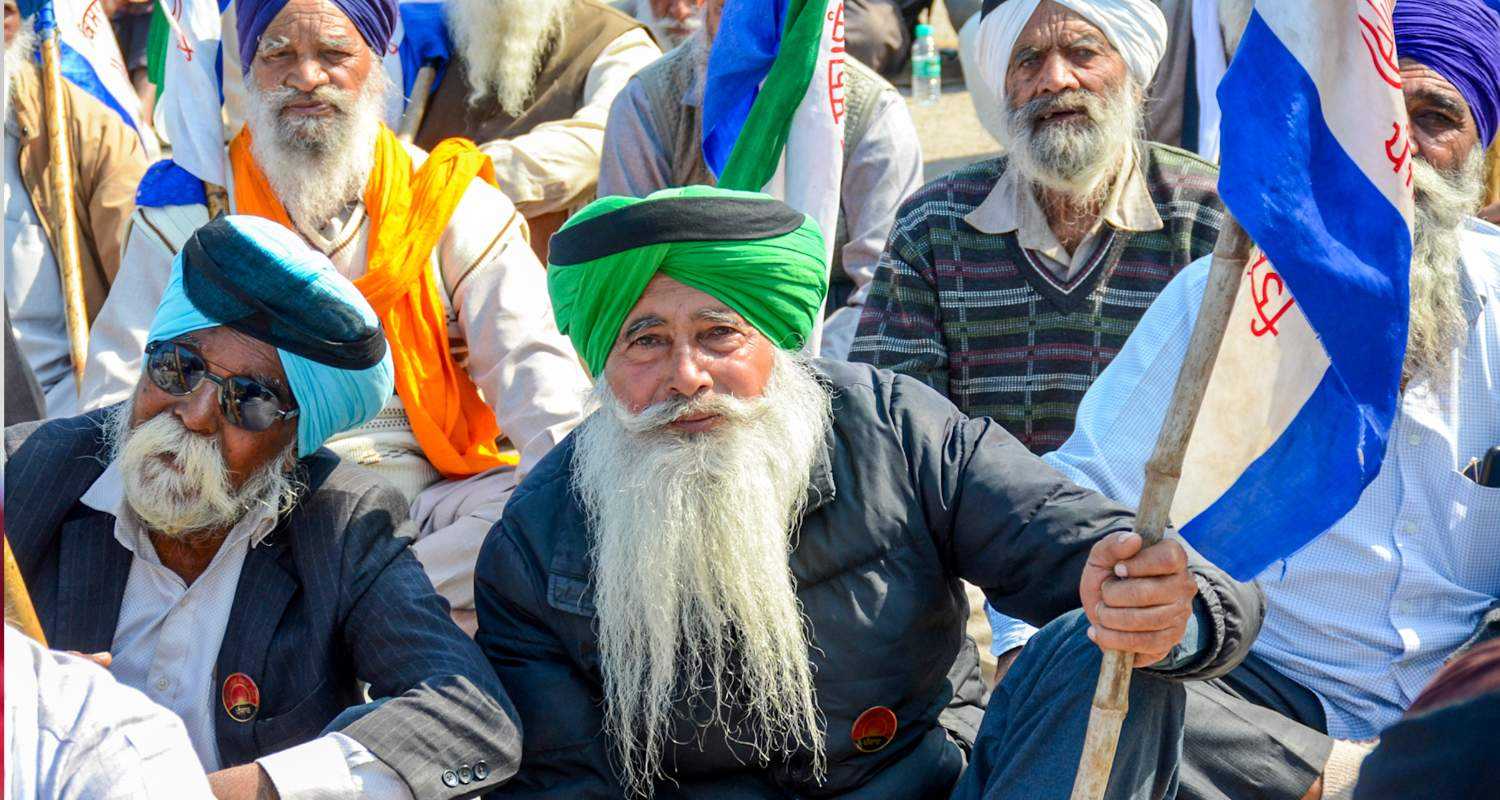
[{"left": 5, "top": 624, "right": 213, "bottom": 800}]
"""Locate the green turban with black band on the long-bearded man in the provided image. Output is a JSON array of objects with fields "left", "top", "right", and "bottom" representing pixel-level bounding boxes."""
[{"left": 548, "top": 186, "right": 828, "bottom": 377}]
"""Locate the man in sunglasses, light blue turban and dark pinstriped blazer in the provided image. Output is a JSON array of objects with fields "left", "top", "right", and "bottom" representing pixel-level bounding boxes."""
[{"left": 5, "top": 216, "right": 519, "bottom": 800}]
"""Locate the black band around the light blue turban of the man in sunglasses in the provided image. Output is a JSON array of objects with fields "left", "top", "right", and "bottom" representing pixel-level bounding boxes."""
[{"left": 182, "top": 216, "right": 386, "bottom": 369}]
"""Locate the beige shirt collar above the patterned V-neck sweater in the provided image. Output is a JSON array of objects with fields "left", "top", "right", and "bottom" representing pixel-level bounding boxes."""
[{"left": 963, "top": 141, "right": 1164, "bottom": 244}]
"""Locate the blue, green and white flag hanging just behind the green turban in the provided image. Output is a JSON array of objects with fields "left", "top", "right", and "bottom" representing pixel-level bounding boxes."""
[{"left": 704, "top": 0, "right": 846, "bottom": 353}]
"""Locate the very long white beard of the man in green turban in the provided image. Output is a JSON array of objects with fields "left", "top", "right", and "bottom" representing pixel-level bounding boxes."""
[{"left": 573, "top": 351, "right": 831, "bottom": 795}]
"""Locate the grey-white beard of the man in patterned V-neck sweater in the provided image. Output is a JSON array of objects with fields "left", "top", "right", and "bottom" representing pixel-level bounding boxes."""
[{"left": 1005, "top": 80, "right": 1143, "bottom": 206}]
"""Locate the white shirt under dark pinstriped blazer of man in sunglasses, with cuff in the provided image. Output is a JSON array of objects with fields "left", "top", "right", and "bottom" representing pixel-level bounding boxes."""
[{"left": 80, "top": 462, "right": 411, "bottom": 800}]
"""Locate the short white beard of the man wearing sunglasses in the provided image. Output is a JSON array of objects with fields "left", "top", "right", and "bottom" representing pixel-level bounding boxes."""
[{"left": 107, "top": 402, "right": 300, "bottom": 542}]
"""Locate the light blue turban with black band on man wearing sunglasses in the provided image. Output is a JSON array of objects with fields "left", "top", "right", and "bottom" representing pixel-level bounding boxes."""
[{"left": 147, "top": 216, "right": 396, "bottom": 456}]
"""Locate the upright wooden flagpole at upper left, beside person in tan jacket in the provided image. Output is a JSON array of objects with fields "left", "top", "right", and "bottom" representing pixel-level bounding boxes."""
[{"left": 38, "top": 3, "right": 89, "bottom": 392}]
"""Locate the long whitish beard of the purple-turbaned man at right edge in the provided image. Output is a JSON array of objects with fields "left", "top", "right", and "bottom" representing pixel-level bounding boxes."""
[{"left": 1401, "top": 149, "right": 1484, "bottom": 384}]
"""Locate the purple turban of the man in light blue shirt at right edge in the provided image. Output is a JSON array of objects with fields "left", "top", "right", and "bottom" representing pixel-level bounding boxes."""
[{"left": 1392, "top": 0, "right": 1500, "bottom": 147}]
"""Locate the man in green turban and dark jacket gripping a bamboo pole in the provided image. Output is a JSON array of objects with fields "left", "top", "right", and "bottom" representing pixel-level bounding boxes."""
[{"left": 476, "top": 186, "right": 1260, "bottom": 798}]
